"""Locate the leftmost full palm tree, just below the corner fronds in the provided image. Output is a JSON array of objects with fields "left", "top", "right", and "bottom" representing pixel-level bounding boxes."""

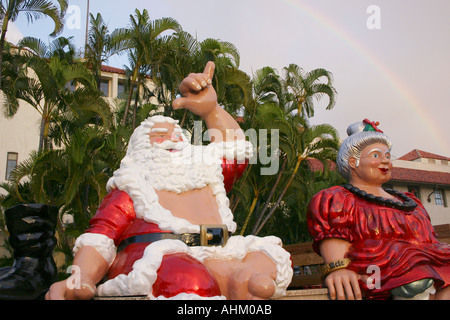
[{"left": 16, "top": 37, "right": 110, "bottom": 151}]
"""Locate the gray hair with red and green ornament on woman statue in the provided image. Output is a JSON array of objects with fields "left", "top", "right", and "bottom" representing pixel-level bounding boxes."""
[{"left": 336, "top": 120, "right": 392, "bottom": 180}]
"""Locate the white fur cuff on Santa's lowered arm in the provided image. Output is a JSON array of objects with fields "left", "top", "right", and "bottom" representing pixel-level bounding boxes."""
[{"left": 73, "top": 233, "right": 117, "bottom": 266}]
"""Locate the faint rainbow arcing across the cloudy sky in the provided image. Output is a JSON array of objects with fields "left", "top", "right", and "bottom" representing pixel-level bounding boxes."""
[{"left": 283, "top": 0, "right": 450, "bottom": 153}]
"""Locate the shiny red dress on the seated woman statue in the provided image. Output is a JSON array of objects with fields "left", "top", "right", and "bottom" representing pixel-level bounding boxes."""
[{"left": 307, "top": 186, "right": 450, "bottom": 298}]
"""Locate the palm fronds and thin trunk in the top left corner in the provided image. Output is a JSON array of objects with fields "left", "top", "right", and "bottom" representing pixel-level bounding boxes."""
[{"left": 0, "top": 0, "right": 68, "bottom": 88}]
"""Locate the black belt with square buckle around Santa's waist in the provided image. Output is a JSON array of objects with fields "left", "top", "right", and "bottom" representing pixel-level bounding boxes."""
[{"left": 117, "top": 225, "right": 229, "bottom": 252}]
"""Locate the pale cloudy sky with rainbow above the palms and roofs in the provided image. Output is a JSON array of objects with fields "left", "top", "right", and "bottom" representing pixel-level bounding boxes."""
[{"left": 7, "top": 0, "right": 450, "bottom": 158}]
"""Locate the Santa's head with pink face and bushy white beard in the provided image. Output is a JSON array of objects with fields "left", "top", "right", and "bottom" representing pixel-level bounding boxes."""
[{"left": 110, "top": 117, "right": 223, "bottom": 193}]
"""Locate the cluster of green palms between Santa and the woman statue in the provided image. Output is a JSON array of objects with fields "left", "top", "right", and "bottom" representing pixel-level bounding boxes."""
[{"left": 231, "top": 64, "right": 339, "bottom": 239}]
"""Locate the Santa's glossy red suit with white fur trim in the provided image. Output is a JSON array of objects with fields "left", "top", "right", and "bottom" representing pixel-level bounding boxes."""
[{"left": 74, "top": 141, "right": 292, "bottom": 299}]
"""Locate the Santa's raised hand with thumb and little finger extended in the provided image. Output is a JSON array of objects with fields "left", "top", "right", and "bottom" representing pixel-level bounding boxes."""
[{"left": 172, "top": 61, "right": 218, "bottom": 118}]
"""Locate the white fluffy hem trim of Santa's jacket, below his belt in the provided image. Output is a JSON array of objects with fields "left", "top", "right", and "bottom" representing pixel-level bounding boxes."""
[{"left": 97, "top": 236, "right": 293, "bottom": 299}]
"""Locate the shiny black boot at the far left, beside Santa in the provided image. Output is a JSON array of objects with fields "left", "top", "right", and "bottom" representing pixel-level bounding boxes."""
[{"left": 0, "top": 204, "right": 58, "bottom": 300}]
